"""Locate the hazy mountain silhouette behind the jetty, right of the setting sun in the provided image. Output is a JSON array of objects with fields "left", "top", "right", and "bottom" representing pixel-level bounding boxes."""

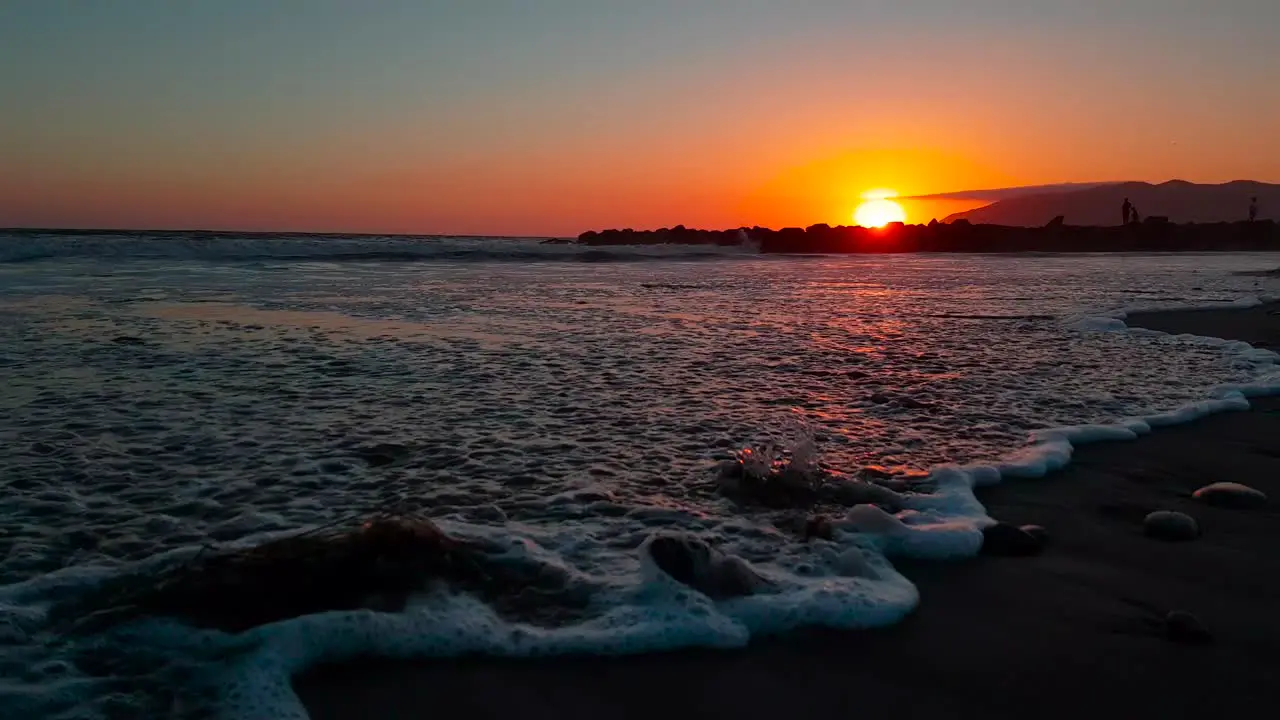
[{"left": 943, "top": 181, "right": 1280, "bottom": 227}]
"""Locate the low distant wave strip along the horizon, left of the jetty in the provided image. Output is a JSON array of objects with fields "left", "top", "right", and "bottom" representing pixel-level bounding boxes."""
[{"left": 0, "top": 233, "right": 756, "bottom": 264}]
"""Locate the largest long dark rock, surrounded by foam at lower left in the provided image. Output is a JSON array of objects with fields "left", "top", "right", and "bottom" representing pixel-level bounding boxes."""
[{"left": 49, "top": 516, "right": 590, "bottom": 633}]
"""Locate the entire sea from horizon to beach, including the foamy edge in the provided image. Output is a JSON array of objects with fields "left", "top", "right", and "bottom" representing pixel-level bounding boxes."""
[{"left": 0, "top": 234, "right": 1280, "bottom": 717}]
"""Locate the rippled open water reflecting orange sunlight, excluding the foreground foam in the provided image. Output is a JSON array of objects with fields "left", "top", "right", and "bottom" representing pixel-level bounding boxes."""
[{"left": 0, "top": 234, "right": 1276, "bottom": 712}]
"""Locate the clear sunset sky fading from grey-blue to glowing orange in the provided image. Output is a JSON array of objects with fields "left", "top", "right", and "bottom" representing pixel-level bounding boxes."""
[{"left": 0, "top": 0, "right": 1280, "bottom": 236}]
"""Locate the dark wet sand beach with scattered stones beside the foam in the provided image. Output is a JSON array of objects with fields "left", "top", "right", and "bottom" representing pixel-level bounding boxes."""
[{"left": 294, "top": 307, "right": 1280, "bottom": 720}]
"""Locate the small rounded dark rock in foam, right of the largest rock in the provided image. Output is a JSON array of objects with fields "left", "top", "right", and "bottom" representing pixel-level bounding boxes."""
[{"left": 644, "top": 533, "right": 768, "bottom": 600}]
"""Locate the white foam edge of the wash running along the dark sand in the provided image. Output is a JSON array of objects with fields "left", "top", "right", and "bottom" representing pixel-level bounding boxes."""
[{"left": 207, "top": 281, "right": 1280, "bottom": 719}]
